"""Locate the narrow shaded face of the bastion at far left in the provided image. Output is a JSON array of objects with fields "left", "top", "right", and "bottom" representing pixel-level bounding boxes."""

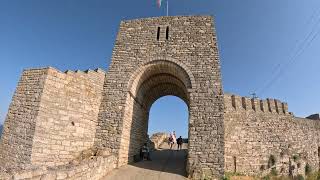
[{"left": 0, "top": 69, "right": 47, "bottom": 168}]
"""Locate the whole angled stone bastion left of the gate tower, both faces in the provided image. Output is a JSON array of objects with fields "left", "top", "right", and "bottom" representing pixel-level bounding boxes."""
[{"left": 0, "top": 68, "right": 105, "bottom": 168}]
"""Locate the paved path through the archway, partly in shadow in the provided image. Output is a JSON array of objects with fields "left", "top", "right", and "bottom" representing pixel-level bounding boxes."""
[{"left": 102, "top": 143, "right": 187, "bottom": 180}]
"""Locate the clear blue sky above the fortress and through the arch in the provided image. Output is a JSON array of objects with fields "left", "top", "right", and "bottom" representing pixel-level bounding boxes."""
[{"left": 0, "top": 0, "right": 320, "bottom": 136}]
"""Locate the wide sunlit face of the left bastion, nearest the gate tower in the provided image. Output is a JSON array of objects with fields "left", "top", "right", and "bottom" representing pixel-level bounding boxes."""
[{"left": 31, "top": 68, "right": 105, "bottom": 166}]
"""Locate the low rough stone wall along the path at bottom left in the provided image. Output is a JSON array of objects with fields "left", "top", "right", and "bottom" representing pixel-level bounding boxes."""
[{"left": 0, "top": 155, "right": 116, "bottom": 180}]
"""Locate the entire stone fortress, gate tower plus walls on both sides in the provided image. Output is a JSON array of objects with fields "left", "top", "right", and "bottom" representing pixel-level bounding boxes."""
[{"left": 0, "top": 16, "right": 320, "bottom": 179}]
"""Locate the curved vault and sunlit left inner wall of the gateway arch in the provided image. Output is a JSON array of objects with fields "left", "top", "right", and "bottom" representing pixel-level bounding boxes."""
[{"left": 119, "top": 60, "right": 193, "bottom": 164}]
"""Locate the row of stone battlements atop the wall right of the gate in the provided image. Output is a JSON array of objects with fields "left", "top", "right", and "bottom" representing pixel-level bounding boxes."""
[{"left": 224, "top": 93, "right": 292, "bottom": 115}]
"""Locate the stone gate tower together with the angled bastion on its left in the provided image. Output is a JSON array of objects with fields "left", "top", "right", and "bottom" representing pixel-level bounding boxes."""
[{"left": 0, "top": 16, "right": 224, "bottom": 179}]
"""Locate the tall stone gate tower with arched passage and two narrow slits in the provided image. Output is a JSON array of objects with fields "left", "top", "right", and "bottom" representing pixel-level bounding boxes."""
[{"left": 95, "top": 16, "right": 224, "bottom": 178}]
